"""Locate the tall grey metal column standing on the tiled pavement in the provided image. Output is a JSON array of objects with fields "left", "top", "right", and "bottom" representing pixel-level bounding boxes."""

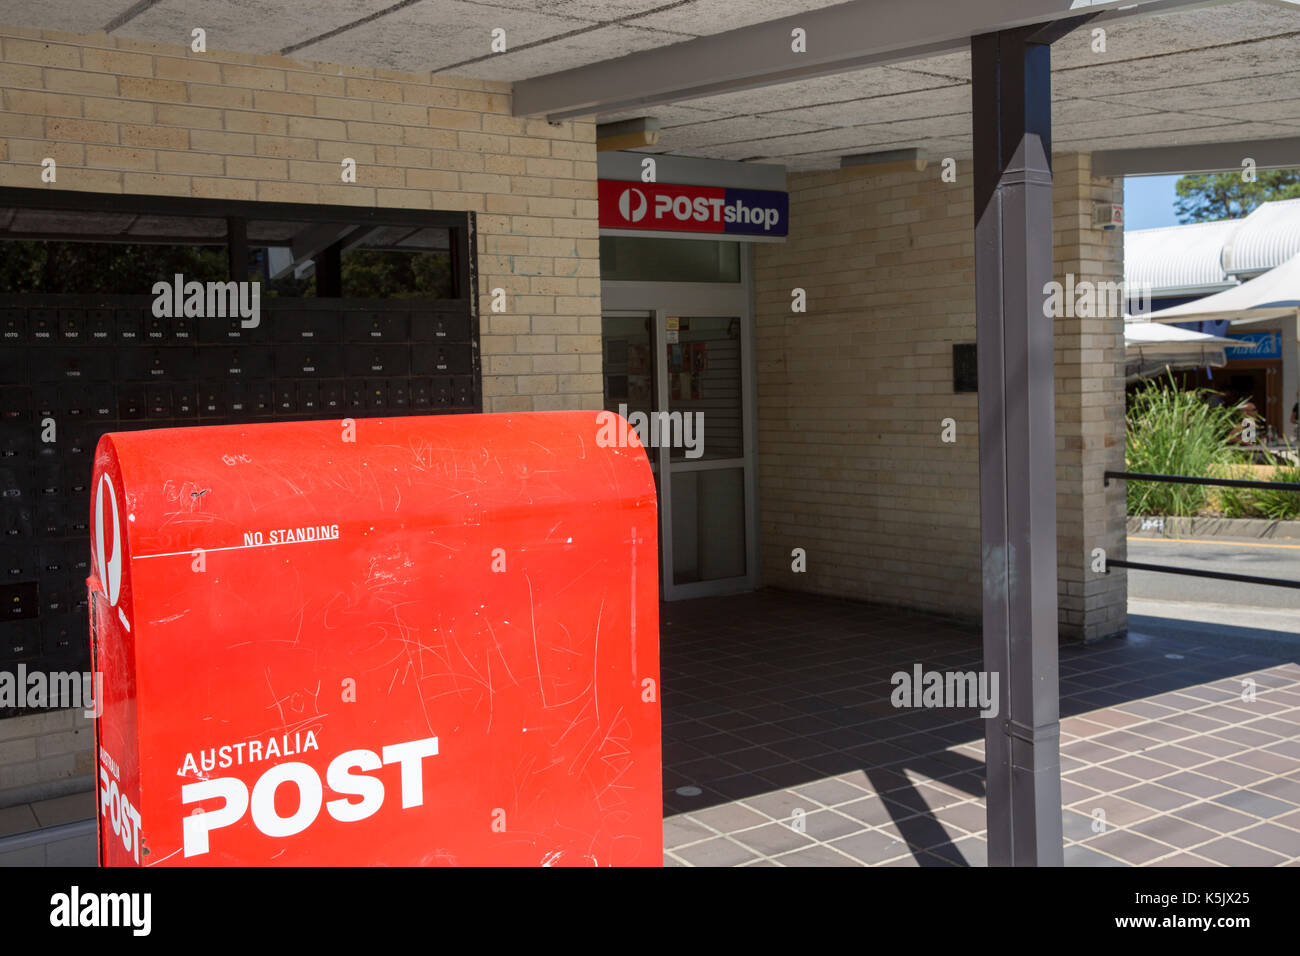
[{"left": 971, "top": 27, "right": 1063, "bottom": 866}]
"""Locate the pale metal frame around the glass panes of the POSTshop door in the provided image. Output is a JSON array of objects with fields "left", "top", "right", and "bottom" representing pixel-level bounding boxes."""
[{"left": 601, "top": 251, "right": 759, "bottom": 601}]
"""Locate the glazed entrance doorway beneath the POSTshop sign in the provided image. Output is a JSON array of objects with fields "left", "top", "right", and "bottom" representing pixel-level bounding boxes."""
[{"left": 601, "top": 241, "right": 758, "bottom": 601}]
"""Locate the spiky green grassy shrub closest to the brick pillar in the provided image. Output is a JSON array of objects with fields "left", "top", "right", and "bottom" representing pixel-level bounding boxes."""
[{"left": 1125, "top": 375, "right": 1242, "bottom": 518}]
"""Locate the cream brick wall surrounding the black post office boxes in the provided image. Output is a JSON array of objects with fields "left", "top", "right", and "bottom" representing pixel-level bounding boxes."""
[{"left": 0, "top": 26, "right": 602, "bottom": 806}]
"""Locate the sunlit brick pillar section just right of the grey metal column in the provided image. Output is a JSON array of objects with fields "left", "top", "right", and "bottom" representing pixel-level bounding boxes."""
[{"left": 1052, "top": 152, "right": 1128, "bottom": 641}]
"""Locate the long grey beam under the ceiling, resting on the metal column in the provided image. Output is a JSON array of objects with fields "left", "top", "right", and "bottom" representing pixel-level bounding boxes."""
[{"left": 514, "top": 0, "right": 1205, "bottom": 120}]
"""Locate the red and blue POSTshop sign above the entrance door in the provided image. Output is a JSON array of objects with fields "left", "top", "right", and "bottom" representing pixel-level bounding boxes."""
[{"left": 598, "top": 179, "right": 790, "bottom": 237}]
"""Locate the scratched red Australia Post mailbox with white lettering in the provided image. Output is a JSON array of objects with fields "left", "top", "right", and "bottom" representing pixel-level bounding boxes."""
[{"left": 90, "top": 412, "right": 662, "bottom": 866}]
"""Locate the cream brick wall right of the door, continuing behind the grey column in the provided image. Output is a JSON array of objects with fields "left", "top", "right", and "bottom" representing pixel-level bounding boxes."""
[{"left": 755, "top": 156, "right": 1125, "bottom": 637}]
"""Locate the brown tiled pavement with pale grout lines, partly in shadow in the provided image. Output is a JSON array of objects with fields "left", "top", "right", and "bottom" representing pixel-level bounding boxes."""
[{"left": 662, "top": 592, "right": 1300, "bottom": 866}]
